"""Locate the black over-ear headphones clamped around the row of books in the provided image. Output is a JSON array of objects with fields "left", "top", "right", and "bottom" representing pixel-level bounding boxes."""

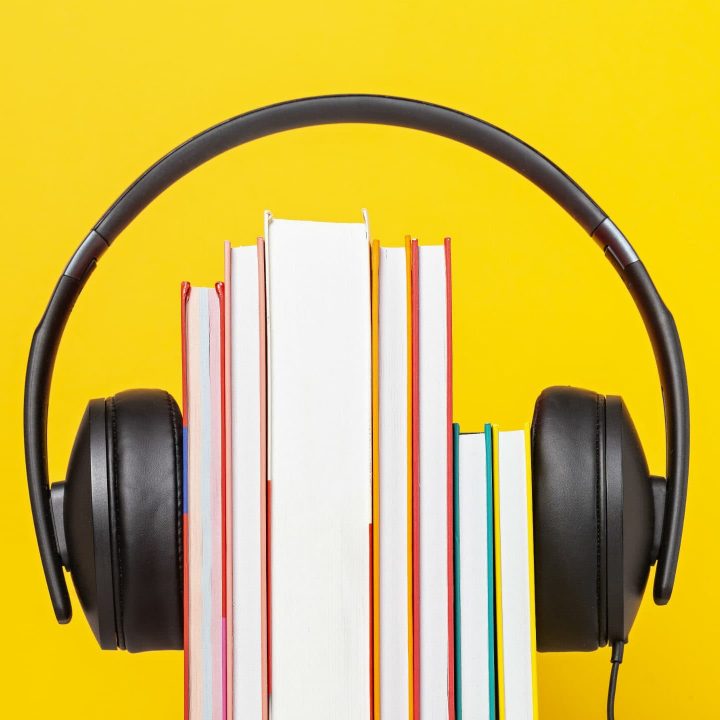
[{"left": 25, "top": 95, "right": 690, "bottom": 651}]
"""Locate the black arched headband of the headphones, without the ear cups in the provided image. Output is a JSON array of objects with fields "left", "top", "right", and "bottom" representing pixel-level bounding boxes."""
[{"left": 25, "top": 95, "right": 690, "bottom": 622}]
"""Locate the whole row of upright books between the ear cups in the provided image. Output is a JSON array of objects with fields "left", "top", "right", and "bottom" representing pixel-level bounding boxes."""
[{"left": 182, "top": 213, "right": 537, "bottom": 720}]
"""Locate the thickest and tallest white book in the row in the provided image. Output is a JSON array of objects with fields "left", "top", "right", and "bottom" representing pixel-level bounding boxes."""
[{"left": 265, "top": 213, "right": 372, "bottom": 720}]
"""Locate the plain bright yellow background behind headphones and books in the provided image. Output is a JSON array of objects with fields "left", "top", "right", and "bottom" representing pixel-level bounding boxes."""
[{"left": 0, "top": 0, "right": 720, "bottom": 719}]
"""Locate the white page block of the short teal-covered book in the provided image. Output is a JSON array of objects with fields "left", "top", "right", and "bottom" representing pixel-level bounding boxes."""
[{"left": 455, "top": 433, "right": 494, "bottom": 720}]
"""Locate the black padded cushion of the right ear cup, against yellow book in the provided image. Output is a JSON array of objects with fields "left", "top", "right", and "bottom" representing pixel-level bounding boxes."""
[{"left": 532, "top": 387, "right": 607, "bottom": 651}]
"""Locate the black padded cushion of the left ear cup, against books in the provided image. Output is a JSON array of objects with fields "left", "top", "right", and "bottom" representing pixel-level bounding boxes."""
[{"left": 105, "top": 390, "right": 183, "bottom": 652}]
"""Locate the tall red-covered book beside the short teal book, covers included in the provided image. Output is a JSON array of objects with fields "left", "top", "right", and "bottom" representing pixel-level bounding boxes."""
[{"left": 411, "top": 239, "right": 455, "bottom": 720}]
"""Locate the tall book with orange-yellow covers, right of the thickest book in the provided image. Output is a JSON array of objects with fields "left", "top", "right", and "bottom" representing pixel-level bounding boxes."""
[{"left": 371, "top": 243, "right": 413, "bottom": 720}]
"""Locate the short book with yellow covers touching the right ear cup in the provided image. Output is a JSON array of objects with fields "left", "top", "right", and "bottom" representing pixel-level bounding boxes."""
[{"left": 493, "top": 427, "right": 537, "bottom": 720}]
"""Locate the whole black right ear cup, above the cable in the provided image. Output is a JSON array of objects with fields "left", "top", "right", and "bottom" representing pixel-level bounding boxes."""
[{"left": 532, "top": 387, "right": 654, "bottom": 651}]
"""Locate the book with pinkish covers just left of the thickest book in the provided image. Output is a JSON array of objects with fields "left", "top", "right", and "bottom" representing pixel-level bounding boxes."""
[{"left": 225, "top": 238, "right": 268, "bottom": 720}]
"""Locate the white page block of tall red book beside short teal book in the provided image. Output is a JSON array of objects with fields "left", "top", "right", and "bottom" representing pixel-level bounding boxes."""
[{"left": 416, "top": 245, "right": 452, "bottom": 720}]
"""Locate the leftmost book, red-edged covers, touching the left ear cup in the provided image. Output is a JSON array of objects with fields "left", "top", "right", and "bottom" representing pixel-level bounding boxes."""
[{"left": 182, "top": 283, "right": 225, "bottom": 720}]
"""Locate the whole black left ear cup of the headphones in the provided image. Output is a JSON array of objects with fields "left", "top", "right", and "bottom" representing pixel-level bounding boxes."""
[{"left": 63, "top": 390, "right": 183, "bottom": 652}]
